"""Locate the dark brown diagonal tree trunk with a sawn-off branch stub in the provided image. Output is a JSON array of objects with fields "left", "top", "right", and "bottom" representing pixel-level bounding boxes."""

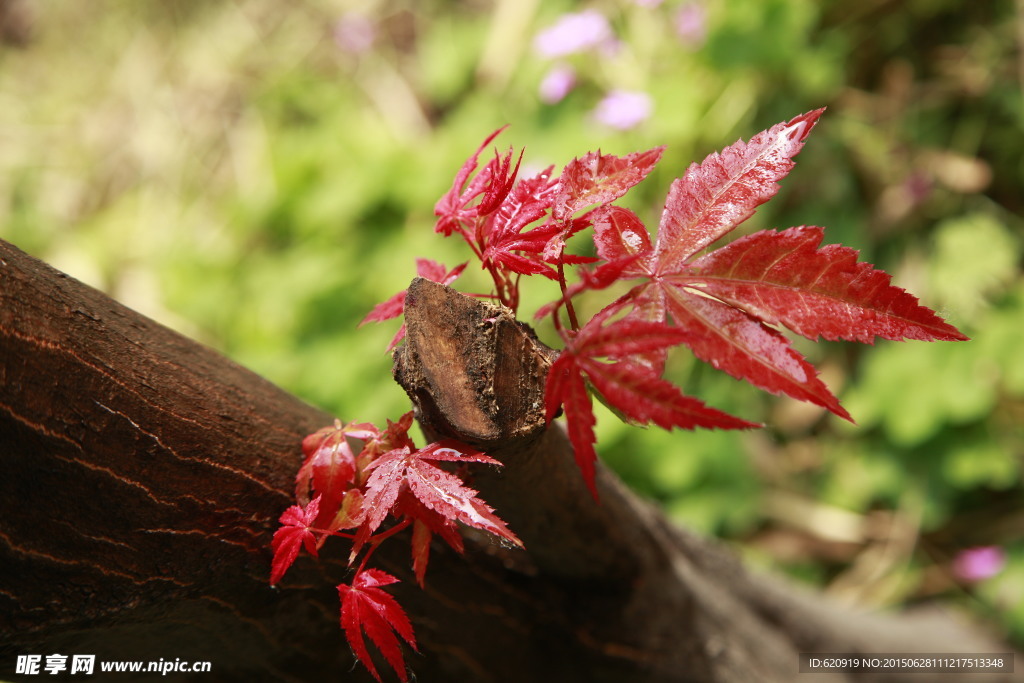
[{"left": 0, "top": 242, "right": 1014, "bottom": 683}]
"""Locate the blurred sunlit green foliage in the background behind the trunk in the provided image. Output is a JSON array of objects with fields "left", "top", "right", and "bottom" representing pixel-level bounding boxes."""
[{"left": 0, "top": 0, "right": 1024, "bottom": 643}]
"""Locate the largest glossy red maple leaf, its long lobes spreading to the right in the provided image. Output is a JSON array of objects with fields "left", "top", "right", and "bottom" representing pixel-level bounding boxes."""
[{"left": 577, "top": 110, "right": 966, "bottom": 419}]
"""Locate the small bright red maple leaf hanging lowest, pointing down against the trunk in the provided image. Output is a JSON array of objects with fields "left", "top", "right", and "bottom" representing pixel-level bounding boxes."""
[{"left": 338, "top": 569, "right": 419, "bottom": 681}]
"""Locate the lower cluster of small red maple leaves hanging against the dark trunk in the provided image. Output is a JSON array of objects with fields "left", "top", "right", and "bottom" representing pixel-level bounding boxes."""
[{"left": 270, "top": 413, "right": 522, "bottom": 681}]
